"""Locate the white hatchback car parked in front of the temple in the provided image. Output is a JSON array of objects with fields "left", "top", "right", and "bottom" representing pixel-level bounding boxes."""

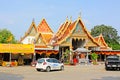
[{"left": 36, "top": 58, "right": 64, "bottom": 72}]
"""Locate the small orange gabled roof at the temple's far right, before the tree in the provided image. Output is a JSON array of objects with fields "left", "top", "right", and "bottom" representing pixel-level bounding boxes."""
[{"left": 94, "top": 34, "right": 110, "bottom": 50}]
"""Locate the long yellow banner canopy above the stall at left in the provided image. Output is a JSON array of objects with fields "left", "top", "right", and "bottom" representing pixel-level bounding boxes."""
[{"left": 0, "top": 44, "right": 34, "bottom": 53}]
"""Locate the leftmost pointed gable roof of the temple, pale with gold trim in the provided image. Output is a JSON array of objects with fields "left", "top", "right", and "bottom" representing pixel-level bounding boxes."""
[{"left": 20, "top": 20, "right": 37, "bottom": 42}]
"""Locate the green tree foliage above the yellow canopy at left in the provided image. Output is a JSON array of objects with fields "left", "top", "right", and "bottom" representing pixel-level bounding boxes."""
[{"left": 0, "top": 29, "right": 17, "bottom": 43}]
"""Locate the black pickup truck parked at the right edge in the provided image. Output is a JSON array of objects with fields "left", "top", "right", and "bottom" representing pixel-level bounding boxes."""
[{"left": 105, "top": 55, "right": 120, "bottom": 70}]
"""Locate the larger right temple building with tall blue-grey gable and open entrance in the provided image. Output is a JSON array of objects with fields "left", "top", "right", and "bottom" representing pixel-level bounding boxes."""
[{"left": 52, "top": 17, "right": 111, "bottom": 60}]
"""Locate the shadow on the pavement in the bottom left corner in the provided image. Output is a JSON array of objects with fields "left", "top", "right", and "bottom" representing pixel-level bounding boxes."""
[{"left": 0, "top": 72, "right": 24, "bottom": 80}]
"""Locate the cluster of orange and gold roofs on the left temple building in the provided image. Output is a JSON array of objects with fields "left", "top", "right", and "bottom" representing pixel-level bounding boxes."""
[{"left": 20, "top": 19, "right": 53, "bottom": 47}]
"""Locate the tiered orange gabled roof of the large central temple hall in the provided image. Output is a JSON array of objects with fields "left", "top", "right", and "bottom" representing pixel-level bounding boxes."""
[{"left": 55, "top": 17, "right": 99, "bottom": 46}]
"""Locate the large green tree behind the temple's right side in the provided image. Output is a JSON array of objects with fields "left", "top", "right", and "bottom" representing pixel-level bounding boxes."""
[{"left": 91, "top": 24, "right": 120, "bottom": 50}]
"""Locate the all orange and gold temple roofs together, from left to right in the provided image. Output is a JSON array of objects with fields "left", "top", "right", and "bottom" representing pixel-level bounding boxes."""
[{"left": 20, "top": 17, "right": 108, "bottom": 49}]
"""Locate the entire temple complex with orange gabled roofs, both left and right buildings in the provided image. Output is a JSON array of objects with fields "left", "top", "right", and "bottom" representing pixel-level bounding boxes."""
[{"left": 20, "top": 17, "right": 119, "bottom": 60}]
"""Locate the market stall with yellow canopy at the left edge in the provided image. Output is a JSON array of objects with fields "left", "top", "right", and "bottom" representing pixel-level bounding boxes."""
[{"left": 0, "top": 44, "right": 34, "bottom": 66}]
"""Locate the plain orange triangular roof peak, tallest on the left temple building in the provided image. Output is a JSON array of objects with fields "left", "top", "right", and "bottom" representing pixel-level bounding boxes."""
[{"left": 37, "top": 19, "right": 53, "bottom": 34}]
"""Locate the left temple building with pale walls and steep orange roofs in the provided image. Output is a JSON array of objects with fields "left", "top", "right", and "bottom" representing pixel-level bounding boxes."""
[{"left": 20, "top": 19, "right": 58, "bottom": 59}]
